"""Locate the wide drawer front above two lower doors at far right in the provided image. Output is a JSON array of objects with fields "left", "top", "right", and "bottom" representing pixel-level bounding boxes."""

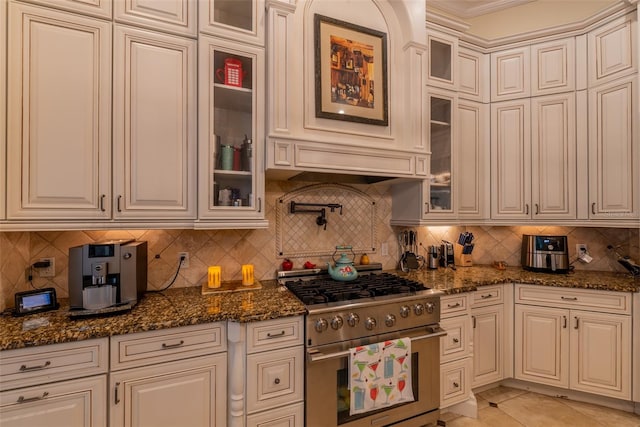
[{"left": 515, "top": 284, "right": 631, "bottom": 314}]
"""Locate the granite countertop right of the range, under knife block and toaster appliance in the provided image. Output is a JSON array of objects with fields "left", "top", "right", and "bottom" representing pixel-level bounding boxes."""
[{"left": 399, "top": 266, "right": 640, "bottom": 294}]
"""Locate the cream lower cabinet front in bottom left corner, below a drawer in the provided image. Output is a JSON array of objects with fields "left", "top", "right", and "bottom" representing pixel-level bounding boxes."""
[{"left": 0, "top": 375, "right": 107, "bottom": 427}]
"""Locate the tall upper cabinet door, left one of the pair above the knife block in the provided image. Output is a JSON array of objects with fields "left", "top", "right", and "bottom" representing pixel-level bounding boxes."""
[{"left": 491, "top": 99, "right": 531, "bottom": 219}]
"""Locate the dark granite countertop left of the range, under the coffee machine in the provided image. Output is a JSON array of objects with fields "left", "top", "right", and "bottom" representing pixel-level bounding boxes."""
[{"left": 0, "top": 280, "right": 306, "bottom": 350}]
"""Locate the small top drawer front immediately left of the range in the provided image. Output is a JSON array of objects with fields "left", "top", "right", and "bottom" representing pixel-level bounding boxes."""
[{"left": 247, "top": 316, "right": 304, "bottom": 354}]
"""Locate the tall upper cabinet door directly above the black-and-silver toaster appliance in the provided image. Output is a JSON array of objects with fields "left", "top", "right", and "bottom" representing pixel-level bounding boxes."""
[{"left": 531, "top": 94, "right": 576, "bottom": 219}]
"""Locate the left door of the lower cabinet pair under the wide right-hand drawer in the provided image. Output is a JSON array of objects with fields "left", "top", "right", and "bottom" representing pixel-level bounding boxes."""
[{"left": 514, "top": 304, "right": 569, "bottom": 388}]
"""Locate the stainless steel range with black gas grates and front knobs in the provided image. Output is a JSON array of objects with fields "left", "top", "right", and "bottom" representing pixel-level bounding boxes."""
[{"left": 278, "top": 264, "right": 445, "bottom": 427}]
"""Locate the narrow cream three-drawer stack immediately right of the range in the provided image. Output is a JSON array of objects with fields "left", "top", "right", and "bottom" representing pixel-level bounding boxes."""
[{"left": 440, "top": 294, "right": 473, "bottom": 409}]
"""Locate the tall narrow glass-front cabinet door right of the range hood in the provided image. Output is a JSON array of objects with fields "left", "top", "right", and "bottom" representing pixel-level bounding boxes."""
[{"left": 425, "top": 89, "right": 456, "bottom": 216}]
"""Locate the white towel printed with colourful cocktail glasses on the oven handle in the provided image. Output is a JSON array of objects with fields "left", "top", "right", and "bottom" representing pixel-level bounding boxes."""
[{"left": 349, "top": 338, "right": 414, "bottom": 415}]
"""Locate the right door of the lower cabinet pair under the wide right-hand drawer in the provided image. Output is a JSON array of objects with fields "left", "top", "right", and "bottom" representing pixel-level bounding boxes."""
[{"left": 571, "top": 310, "right": 631, "bottom": 400}]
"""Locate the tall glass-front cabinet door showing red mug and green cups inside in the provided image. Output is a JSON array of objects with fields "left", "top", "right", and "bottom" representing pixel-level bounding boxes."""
[{"left": 198, "top": 36, "right": 266, "bottom": 228}]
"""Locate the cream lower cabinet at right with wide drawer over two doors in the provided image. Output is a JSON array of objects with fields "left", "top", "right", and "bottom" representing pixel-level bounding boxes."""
[{"left": 514, "top": 285, "right": 631, "bottom": 400}]
